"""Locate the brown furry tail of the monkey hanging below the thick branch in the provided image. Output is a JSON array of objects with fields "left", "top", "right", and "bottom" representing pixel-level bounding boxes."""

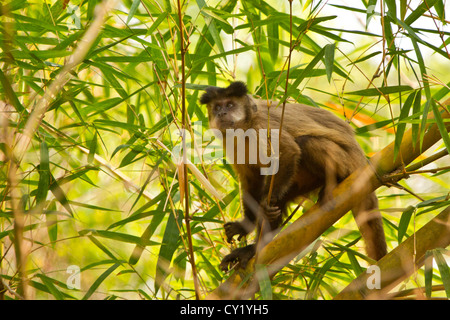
[{"left": 352, "top": 193, "right": 387, "bottom": 260}]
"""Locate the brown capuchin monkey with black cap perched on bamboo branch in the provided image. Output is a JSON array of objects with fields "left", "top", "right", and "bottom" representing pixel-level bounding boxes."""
[{"left": 200, "top": 82, "right": 387, "bottom": 271}]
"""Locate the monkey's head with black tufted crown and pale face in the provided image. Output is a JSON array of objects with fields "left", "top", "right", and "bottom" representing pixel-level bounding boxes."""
[{"left": 200, "top": 81, "right": 257, "bottom": 132}]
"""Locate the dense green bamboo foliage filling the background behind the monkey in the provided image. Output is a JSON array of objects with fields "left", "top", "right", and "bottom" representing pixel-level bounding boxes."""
[{"left": 0, "top": 0, "right": 450, "bottom": 299}]
